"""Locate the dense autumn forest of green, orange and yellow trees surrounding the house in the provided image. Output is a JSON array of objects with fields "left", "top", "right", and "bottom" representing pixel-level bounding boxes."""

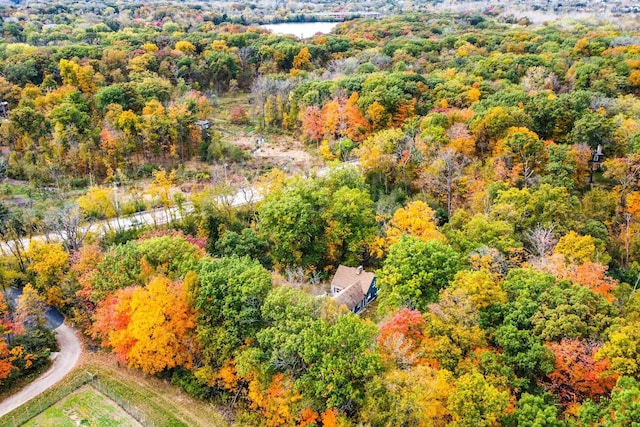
[{"left": 0, "top": 6, "right": 640, "bottom": 427}]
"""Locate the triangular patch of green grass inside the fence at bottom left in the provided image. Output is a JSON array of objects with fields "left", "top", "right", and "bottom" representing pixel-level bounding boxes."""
[{"left": 25, "top": 386, "right": 140, "bottom": 427}]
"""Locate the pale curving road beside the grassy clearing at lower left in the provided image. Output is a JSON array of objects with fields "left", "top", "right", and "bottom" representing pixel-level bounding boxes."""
[{"left": 0, "top": 323, "right": 82, "bottom": 417}]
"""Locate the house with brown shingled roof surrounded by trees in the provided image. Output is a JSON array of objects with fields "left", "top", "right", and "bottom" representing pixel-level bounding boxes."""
[{"left": 331, "top": 265, "right": 378, "bottom": 313}]
